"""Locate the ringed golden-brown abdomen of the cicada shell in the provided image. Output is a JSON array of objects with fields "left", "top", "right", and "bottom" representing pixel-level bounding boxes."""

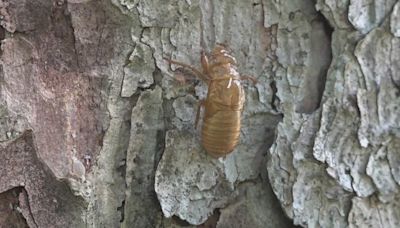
[{"left": 201, "top": 110, "right": 241, "bottom": 157}]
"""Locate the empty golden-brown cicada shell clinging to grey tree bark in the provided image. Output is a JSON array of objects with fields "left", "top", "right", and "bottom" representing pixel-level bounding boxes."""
[{"left": 164, "top": 44, "right": 256, "bottom": 158}]
